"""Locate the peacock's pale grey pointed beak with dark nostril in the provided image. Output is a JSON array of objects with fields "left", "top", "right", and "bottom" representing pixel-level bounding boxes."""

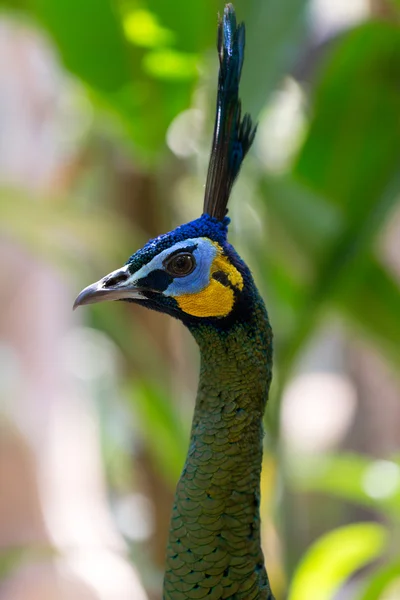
[{"left": 73, "top": 265, "right": 146, "bottom": 310}]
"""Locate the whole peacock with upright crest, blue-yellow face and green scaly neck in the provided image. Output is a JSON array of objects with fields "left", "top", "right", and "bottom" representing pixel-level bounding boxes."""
[{"left": 74, "top": 4, "right": 273, "bottom": 600}]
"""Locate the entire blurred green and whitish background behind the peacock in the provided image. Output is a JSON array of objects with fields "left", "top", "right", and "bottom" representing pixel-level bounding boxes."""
[{"left": 0, "top": 0, "right": 400, "bottom": 600}]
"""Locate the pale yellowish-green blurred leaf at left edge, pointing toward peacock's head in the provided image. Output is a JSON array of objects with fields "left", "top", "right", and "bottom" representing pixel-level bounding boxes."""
[{"left": 0, "top": 189, "right": 133, "bottom": 275}]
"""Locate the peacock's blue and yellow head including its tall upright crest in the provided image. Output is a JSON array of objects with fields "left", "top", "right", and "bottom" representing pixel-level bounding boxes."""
[{"left": 74, "top": 4, "right": 256, "bottom": 325}]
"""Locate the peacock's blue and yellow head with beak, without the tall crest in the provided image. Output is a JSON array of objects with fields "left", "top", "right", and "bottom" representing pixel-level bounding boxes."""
[{"left": 74, "top": 214, "right": 252, "bottom": 325}]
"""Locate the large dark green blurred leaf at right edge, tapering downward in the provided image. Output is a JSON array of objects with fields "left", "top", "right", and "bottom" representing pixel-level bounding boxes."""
[{"left": 264, "top": 22, "right": 400, "bottom": 379}]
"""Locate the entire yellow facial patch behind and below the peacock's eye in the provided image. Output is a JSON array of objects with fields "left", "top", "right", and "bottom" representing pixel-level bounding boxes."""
[{"left": 175, "top": 242, "right": 244, "bottom": 317}]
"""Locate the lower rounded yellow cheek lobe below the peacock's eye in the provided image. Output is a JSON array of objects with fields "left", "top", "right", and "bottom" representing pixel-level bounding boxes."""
[{"left": 175, "top": 279, "right": 235, "bottom": 317}]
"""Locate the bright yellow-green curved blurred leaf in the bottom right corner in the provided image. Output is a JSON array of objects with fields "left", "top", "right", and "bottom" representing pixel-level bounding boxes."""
[{"left": 288, "top": 523, "right": 387, "bottom": 600}]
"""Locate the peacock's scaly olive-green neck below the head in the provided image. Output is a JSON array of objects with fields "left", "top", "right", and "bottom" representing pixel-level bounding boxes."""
[{"left": 164, "top": 291, "right": 273, "bottom": 600}]
